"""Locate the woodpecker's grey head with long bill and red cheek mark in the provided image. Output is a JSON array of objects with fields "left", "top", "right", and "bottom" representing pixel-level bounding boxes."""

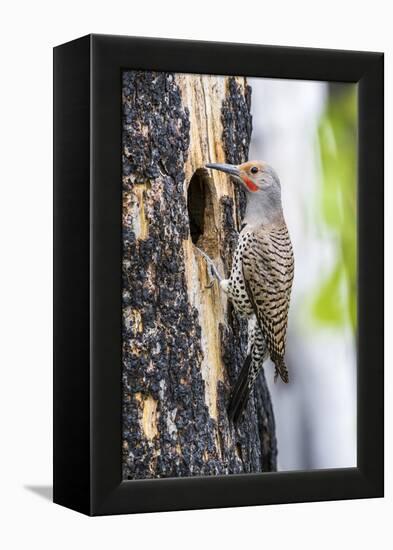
[{"left": 206, "top": 160, "right": 282, "bottom": 223}]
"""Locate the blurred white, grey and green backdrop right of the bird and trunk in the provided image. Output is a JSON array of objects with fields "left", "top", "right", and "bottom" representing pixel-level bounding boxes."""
[{"left": 248, "top": 78, "right": 357, "bottom": 470}]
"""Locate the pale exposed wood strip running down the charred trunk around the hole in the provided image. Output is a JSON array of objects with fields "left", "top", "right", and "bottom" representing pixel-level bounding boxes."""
[{"left": 176, "top": 75, "right": 239, "bottom": 419}]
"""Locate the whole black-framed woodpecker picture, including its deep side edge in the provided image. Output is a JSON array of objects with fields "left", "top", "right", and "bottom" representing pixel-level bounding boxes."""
[{"left": 54, "top": 35, "right": 383, "bottom": 515}]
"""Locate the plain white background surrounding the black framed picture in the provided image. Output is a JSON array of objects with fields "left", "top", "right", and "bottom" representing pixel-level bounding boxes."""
[{"left": 0, "top": 0, "right": 393, "bottom": 550}]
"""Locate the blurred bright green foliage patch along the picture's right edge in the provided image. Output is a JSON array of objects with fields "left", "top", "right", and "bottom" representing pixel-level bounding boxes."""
[{"left": 311, "top": 85, "right": 357, "bottom": 330}]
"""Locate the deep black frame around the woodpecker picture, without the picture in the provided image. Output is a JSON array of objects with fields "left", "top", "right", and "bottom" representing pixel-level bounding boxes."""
[{"left": 54, "top": 35, "right": 384, "bottom": 515}]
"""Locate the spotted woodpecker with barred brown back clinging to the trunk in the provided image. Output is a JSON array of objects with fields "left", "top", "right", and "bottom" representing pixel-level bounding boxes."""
[{"left": 206, "top": 161, "right": 294, "bottom": 423}]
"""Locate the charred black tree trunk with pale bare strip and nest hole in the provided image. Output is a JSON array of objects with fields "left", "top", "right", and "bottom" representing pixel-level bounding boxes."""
[{"left": 123, "top": 71, "right": 277, "bottom": 479}]
